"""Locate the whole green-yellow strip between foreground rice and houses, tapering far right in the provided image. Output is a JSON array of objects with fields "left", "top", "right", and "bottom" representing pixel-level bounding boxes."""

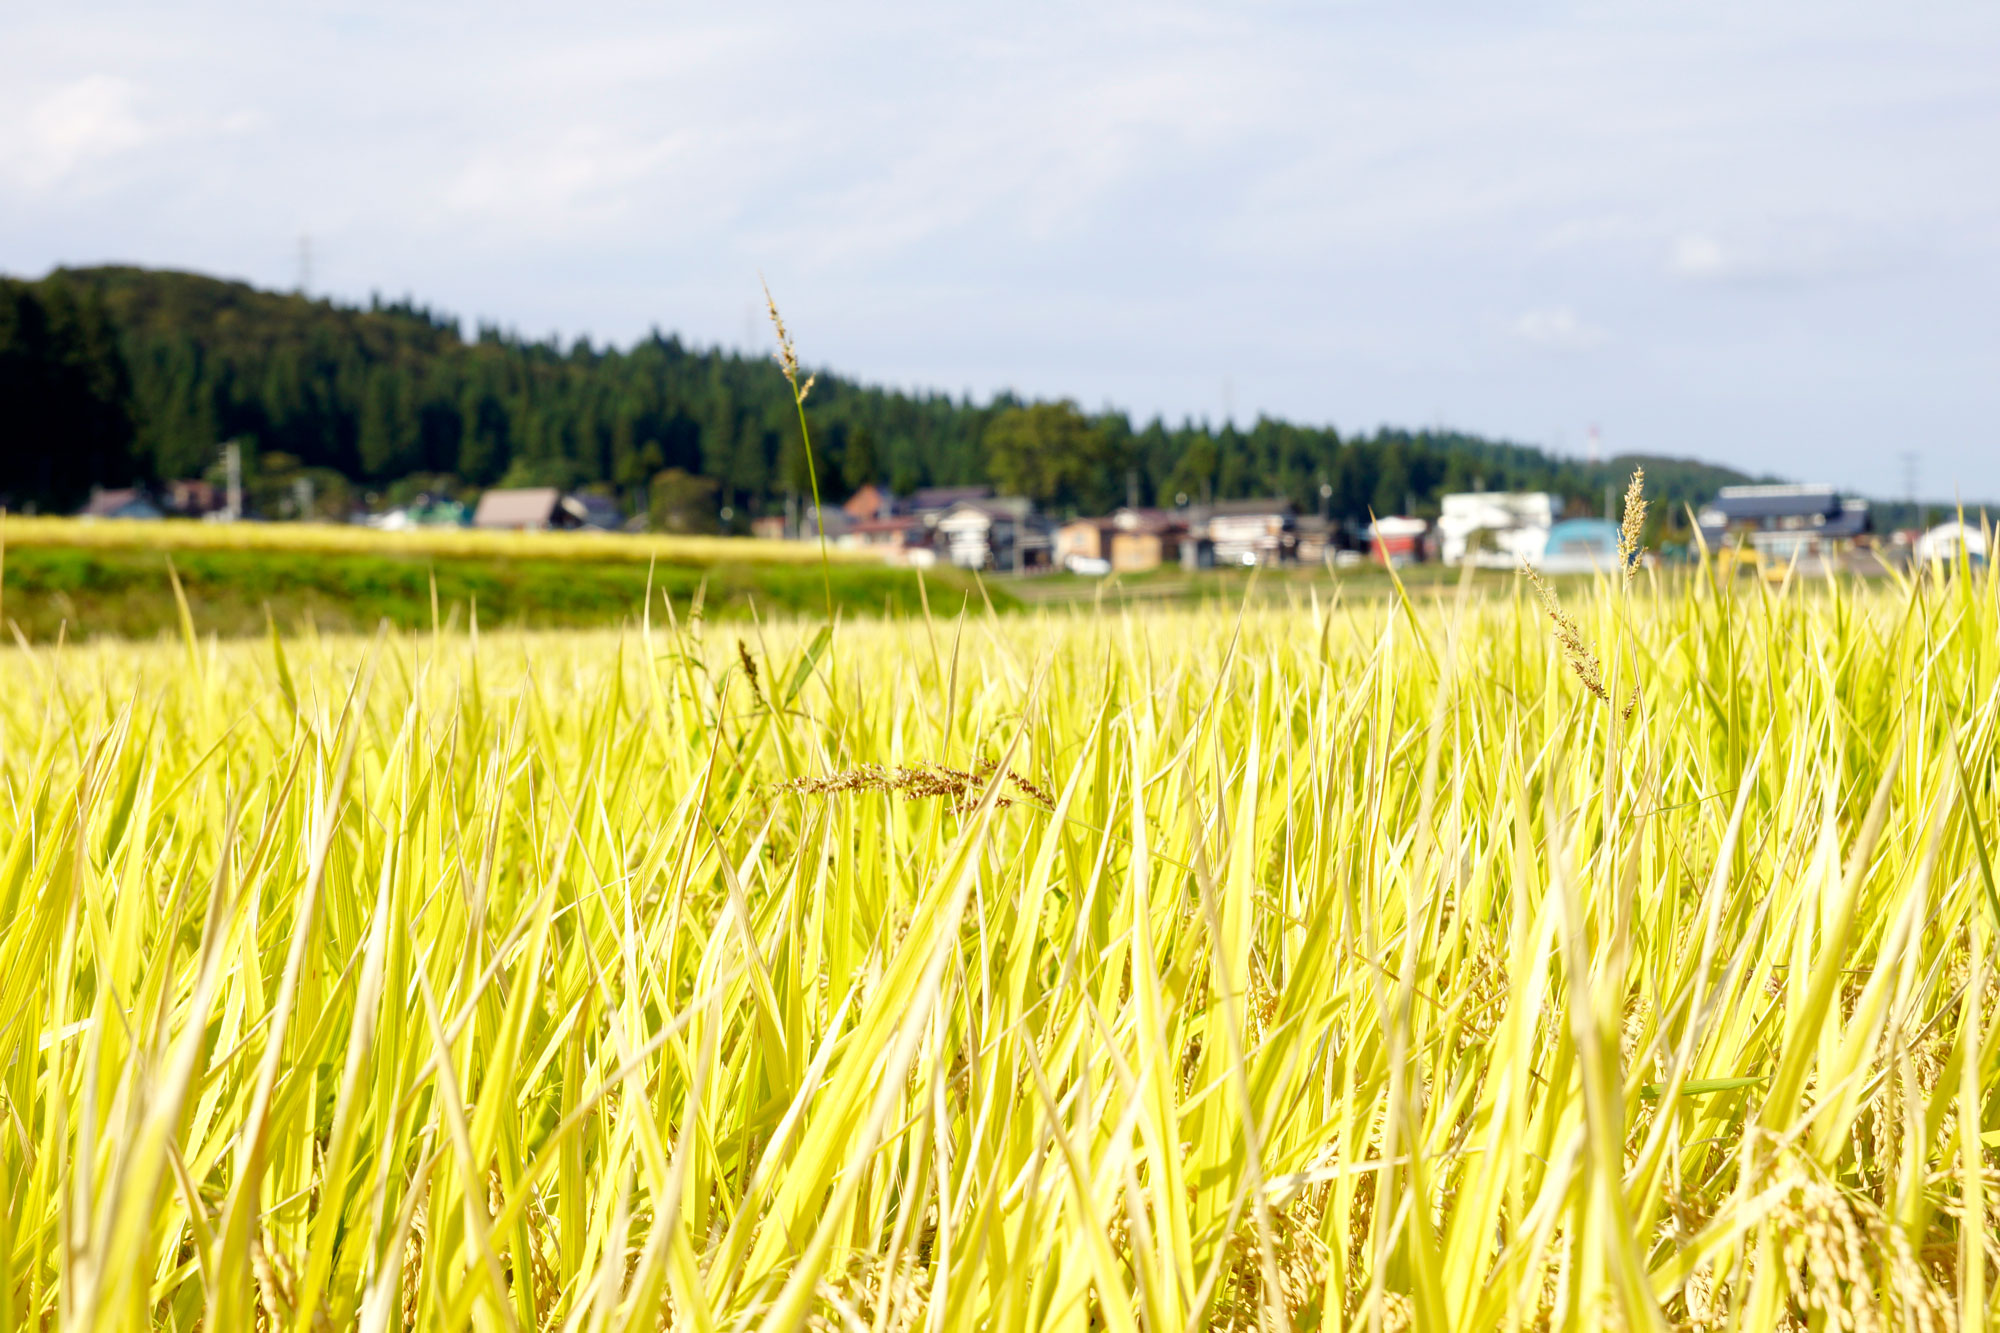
[{"left": 0, "top": 518, "right": 1552, "bottom": 642}]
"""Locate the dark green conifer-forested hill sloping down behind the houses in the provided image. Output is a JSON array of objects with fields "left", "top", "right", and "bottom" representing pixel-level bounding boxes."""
[{"left": 0, "top": 268, "right": 1748, "bottom": 528}]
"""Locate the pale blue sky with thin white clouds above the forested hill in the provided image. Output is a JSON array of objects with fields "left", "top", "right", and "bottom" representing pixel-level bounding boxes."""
[{"left": 0, "top": 0, "right": 2000, "bottom": 498}]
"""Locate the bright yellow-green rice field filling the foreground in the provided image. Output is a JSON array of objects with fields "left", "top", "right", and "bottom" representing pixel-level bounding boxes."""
[{"left": 0, "top": 548, "right": 2000, "bottom": 1333}]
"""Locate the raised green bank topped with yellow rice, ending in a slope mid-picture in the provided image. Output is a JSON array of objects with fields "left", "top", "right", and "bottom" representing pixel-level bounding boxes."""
[{"left": 0, "top": 512, "right": 968, "bottom": 642}]
